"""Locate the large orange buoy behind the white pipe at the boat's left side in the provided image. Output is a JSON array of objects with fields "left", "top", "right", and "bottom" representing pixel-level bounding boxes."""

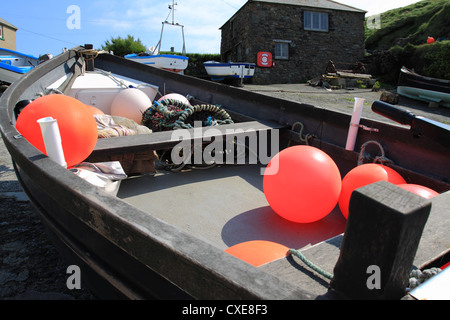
[{"left": 16, "top": 94, "right": 97, "bottom": 167}]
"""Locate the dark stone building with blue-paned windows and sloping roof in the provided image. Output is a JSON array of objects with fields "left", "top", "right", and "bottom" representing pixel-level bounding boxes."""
[{"left": 220, "top": 0, "right": 366, "bottom": 84}]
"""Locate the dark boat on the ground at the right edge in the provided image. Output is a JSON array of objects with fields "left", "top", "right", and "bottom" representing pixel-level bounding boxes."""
[{"left": 397, "top": 67, "right": 450, "bottom": 108}]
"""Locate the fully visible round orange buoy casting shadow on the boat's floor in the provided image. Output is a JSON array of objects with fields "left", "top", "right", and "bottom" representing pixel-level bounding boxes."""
[{"left": 263, "top": 146, "right": 341, "bottom": 223}]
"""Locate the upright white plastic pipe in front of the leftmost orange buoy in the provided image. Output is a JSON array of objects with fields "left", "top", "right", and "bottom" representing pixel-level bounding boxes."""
[{"left": 37, "top": 117, "right": 67, "bottom": 168}]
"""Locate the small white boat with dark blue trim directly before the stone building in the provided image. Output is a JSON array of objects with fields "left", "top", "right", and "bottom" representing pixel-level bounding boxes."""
[{"left": 203, "top": 61, "right": 255, "bottom": 80}]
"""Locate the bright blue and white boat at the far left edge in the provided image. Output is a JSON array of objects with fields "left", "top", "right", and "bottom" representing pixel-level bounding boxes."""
[{"left": 0, "top": 48, "right": 38, "bottom": 83}]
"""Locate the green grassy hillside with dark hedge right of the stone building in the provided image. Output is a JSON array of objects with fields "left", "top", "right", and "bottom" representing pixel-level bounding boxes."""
[{"left": 365, "top": 0, "right": 450, "bottom": 85}]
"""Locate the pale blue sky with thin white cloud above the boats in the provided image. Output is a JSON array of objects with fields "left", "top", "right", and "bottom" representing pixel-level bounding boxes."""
[{"left": 0, "top": 0, "right": 419, "bottom": 56}]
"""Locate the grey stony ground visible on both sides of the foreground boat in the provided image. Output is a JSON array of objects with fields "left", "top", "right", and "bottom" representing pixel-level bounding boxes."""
[{"left": 0, "top": 84, "right": 450, "bottom": 300}]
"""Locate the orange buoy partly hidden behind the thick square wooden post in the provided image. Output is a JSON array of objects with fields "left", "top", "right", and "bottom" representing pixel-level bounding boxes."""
[{"left": 339, "top": 163, "right": 406, "bottom": 218}]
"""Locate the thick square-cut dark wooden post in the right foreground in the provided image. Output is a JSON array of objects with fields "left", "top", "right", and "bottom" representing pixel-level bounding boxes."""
[{"left": 330, "top": 181, "right": 431, "bottom": 299}]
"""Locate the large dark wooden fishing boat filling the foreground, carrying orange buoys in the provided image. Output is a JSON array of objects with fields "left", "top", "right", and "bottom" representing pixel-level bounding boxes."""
[{"left": 0, "top": 47, "right": 450, "bottom": 302}]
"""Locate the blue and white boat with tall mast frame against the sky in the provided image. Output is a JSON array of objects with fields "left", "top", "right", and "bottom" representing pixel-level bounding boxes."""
[{"left": 125, "top": 1, "right": 189, "bottom": 73}]
